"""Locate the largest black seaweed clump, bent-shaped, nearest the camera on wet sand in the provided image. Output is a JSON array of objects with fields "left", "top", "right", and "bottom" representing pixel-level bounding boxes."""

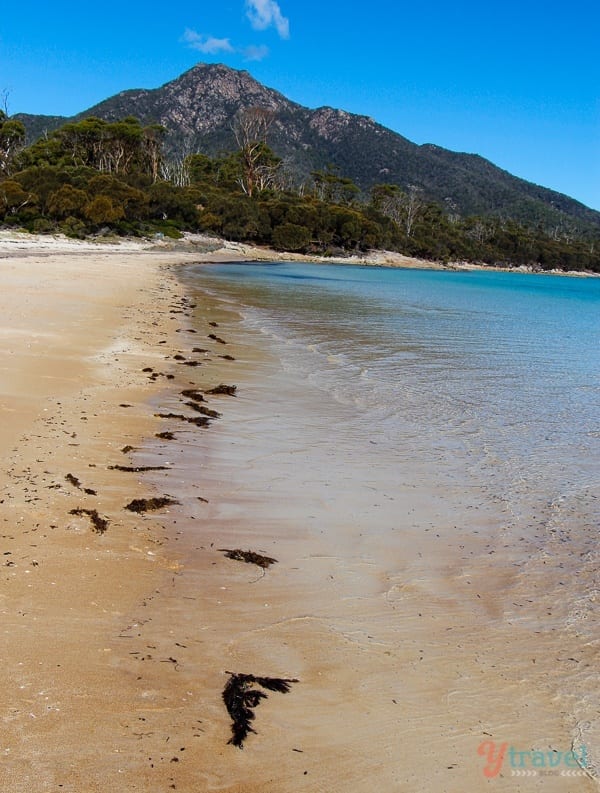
[{"left": 222, "top": 672, "right": 298, "bottom": 749}]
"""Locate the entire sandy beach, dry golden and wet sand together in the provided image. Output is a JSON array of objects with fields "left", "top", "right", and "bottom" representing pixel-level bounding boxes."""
[{"left": 0, "top": 227, "right": 595, "bottom": 793}]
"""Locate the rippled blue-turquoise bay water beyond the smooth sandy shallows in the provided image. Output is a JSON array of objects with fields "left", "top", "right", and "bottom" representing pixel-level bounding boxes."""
[{"left": 189, "top": 264, "right": 600, "bottom": 530}]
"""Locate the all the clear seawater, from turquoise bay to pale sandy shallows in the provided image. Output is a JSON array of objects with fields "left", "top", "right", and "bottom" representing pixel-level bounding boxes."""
[{"left": 177, "top": 263, "right": 600, "bottom": 790}]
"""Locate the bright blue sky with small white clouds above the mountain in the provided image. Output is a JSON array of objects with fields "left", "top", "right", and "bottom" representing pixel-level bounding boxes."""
[{"left": 0, "top": 0, "right": 600, "bottom": 210}]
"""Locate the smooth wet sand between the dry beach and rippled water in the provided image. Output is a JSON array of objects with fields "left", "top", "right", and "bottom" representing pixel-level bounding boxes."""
[{"left": 144, "top": 282, "right": 594, "bottom": 791}]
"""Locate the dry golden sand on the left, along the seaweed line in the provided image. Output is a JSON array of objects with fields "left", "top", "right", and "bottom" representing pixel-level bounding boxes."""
[{"left": 0, "top": 235, "right": 230, "bottom": 793}]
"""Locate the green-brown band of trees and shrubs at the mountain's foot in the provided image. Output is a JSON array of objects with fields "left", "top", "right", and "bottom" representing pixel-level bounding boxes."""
[{"left": 0, "top": 108, "right": 600, "bottom": 272}]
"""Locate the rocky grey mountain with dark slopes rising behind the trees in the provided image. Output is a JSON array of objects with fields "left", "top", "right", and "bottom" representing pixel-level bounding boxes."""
[{"left": 16, "top": 63, "right": 600, "bottom": 232}]
